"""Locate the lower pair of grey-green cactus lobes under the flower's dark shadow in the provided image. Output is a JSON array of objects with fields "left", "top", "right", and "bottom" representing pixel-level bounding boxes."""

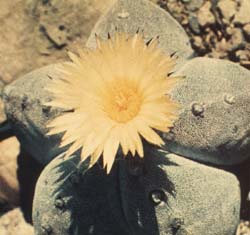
[{"left": 33, "top": 152, "right": 240, "bottom": 235}]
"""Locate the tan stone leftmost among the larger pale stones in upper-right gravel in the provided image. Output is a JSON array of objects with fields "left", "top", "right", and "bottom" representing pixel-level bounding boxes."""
[{"left": 197, "top": 2, "right": 215, "bottom": 27}]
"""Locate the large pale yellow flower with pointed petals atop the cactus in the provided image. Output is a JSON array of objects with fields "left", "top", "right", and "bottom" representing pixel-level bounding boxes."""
[{"left": 46, "top": 33, "right": 178, "bottom": 173}]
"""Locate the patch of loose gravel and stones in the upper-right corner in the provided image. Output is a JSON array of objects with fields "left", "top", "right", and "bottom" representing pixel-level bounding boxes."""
[{"left": 154, "top": 0, "right": 250, "bottom": 69}]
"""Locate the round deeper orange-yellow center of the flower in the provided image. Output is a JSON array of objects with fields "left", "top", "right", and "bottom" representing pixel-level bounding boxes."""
[{"left": 104, "top": 79, "right": 142, "bottom": 123}]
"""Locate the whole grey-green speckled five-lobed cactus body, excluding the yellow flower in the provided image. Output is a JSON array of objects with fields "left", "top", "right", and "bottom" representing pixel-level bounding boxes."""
[{"left": 0, "top": 0, "right": 250, "bottom": 235}]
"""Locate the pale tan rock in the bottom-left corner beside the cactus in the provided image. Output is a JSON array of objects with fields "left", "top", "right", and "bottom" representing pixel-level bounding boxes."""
[{"left": 0, "top": 208, "right": 34, "bottom": 235}]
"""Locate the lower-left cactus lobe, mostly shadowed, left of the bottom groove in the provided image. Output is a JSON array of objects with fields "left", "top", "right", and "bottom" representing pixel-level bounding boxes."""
[{"left": 33, "top": 155, "right": 133, "bottom": 235}]
